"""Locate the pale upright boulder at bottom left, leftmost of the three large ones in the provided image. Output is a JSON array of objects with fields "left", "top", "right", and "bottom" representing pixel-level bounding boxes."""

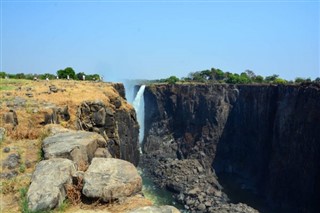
[{"left": 27, "top": 158, "right": 76, "bottom": 211}]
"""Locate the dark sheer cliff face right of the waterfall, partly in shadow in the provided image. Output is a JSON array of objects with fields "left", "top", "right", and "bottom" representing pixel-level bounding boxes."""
[{"left": 143, "top": 84, "right": 320, "bottom": 212}]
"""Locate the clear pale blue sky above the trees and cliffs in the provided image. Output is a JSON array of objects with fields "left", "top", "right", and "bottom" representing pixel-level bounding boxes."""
[{"left": 0, "top": 0, "right": 320, "bottom": 81}]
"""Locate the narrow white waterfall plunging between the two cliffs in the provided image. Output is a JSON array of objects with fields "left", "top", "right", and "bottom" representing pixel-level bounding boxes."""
[{"left": 133, "top": 85, "right": 146, "bottom": 145}]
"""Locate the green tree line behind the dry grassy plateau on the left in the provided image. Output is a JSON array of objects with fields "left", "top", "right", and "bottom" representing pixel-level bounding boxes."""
[{"left": 0, "top": 67, "right": 102, "bottom": 81}]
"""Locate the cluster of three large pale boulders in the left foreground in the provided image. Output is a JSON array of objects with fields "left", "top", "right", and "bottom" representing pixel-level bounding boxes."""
[{"left": 28, "top": 125, "right": 142, "bottom": 211}]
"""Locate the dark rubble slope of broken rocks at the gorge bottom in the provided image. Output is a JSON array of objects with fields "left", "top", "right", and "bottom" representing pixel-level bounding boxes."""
[{"left": 141, "top": 155, "right": 228, "bottom": 212}]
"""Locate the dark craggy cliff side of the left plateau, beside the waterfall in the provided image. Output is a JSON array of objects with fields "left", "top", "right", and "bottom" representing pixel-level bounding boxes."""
[{"left": 77, "top": 98, "right": 139, "bottom": 165}]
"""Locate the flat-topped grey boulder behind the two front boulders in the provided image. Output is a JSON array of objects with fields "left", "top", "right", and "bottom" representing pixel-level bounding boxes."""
[{"left": 42, "top": 130, "right": 106, "bottom": 165}]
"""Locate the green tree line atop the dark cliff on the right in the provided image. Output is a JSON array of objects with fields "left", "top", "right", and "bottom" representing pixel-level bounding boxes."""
[{"left": 149, "top": 68, "right": 320, "bottom": 84}]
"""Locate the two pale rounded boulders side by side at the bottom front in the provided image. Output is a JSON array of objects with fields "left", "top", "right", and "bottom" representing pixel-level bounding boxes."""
[{"left": 27, "top": 158, "right": 142, "bottom": 211}]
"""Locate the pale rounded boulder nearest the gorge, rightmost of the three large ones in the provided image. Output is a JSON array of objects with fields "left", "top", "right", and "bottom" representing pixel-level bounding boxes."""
[{"left": 82, "top": 158, "right": 142, "bottom": 201}]
